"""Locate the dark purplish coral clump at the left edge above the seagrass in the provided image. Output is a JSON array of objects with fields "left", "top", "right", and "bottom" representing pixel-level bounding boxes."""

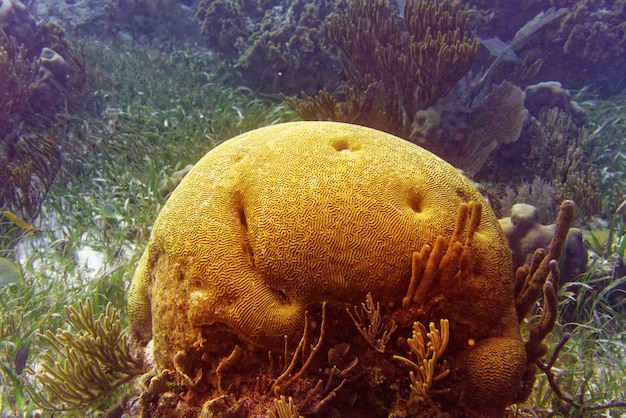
[{"left": 0, "top": 13, "right": 85, "bottom": 236}]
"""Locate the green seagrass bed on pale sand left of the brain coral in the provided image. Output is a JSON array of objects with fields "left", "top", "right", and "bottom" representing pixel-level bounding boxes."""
[{"left": 0, "top": 38, "right": 295, "bottom": 416}]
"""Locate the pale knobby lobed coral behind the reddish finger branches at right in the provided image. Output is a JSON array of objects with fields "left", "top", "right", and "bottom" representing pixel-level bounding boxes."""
[{"left": 500, "top": 203, "right": 587, "bottom": 284}]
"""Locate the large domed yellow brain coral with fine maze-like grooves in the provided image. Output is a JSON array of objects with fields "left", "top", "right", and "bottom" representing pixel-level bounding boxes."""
[{"left": 128, "top": 122, "right": 525, "bottom": 411}]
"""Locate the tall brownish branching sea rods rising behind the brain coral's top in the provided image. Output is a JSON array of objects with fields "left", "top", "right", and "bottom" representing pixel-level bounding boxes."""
[{"left": 285, "top": 0, "right": 478, "bottom": 138}]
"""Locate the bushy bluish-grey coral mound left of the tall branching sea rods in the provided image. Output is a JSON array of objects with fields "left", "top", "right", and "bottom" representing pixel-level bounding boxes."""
[{"left": 196, "top": 0, "right": 345, "bottom": 94}]
